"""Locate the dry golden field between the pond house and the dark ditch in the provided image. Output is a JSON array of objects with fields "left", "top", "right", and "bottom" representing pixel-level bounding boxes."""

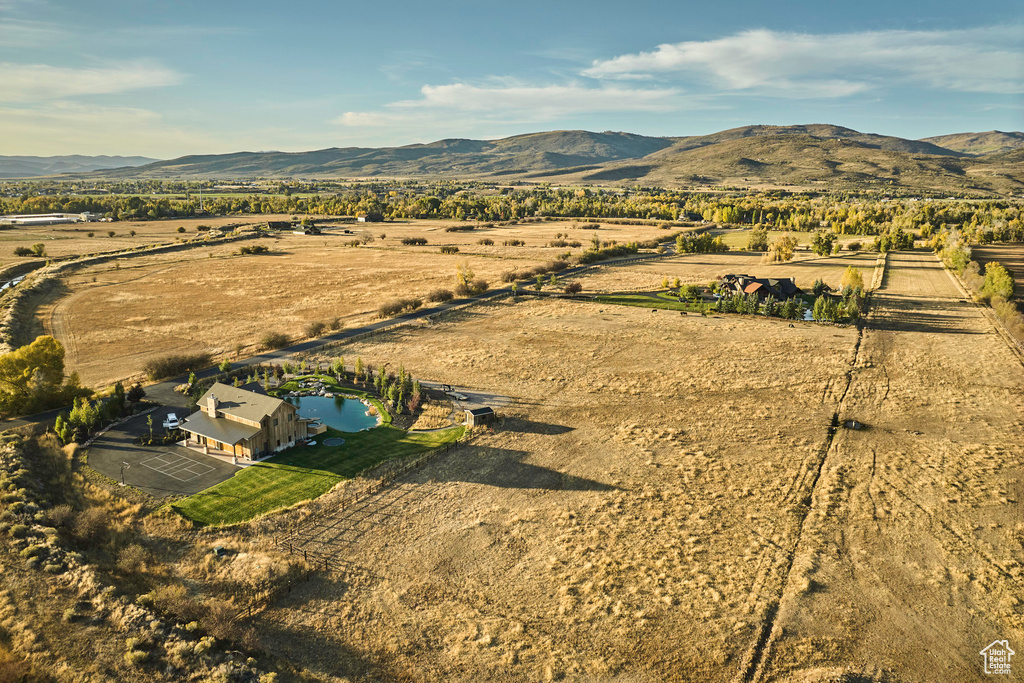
[{"left": 253, "top": 300, "right": 857, "bottom": 681}]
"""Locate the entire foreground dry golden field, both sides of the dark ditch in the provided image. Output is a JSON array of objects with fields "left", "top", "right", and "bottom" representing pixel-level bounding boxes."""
[{"left": 237, "top": 248, "right": 1024, "bottom": 682}]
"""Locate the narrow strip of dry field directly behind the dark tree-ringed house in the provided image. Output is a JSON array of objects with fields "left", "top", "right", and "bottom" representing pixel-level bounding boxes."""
[{"left": 579, "top": 252, "right": 878, "bottom": 292}]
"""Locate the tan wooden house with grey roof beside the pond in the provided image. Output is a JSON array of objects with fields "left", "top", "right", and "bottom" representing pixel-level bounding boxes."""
[{"left": 181, "top": 382, "right": 309, "bottom": 460}]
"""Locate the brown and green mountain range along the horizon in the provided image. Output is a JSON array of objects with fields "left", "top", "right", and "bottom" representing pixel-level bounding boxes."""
[{"left": 8, "top": 124, "right": 1024, "bottom": 196}]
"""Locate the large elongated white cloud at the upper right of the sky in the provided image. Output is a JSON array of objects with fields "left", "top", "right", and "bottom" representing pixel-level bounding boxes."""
[{"left": 583, "top": 27, "right": 1024, "bottom": 97}]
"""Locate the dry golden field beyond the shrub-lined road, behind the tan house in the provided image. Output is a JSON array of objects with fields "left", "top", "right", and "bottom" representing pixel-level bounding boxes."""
[{"left": 38, "top": 221, "right": 667, "bottom": 386}]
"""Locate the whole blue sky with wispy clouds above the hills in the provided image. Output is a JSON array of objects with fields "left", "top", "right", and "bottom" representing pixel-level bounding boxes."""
[{"left": 0, "top": 0, "right": 1024, "bottom": 159}]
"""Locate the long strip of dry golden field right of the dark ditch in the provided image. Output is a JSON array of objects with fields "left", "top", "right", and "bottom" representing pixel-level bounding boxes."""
[{"left": 761, "top": 253, "right": 1024, "bottom": 681}]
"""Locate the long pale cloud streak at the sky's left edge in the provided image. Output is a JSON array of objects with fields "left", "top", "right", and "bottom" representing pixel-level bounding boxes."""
[{"left": 0, "top": 61, "right": 183, "bottom": 103}]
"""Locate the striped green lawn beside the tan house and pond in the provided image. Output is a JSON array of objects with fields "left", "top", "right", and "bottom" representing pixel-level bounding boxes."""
[{"left": 171, "top": 425, "right": 465, "bottom": 524}]
